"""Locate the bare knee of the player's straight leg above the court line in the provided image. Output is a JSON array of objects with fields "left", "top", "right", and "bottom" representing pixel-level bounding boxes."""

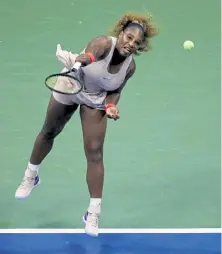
[{"left": 85, "top": 141, "right": 103, "bottom": 163}]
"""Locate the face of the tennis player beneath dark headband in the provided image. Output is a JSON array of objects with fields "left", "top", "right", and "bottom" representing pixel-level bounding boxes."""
[{"left": 116, "top": 27, "right": 144, "bottom": 57}]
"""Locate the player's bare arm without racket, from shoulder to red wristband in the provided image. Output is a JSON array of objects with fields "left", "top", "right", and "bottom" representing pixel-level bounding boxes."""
[{"left": 106, "top": 59, "right": 136, "bottom": 105}]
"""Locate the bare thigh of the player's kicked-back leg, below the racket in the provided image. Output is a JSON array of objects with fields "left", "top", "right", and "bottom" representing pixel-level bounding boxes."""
[{"left": 42, "top": 95, "right": 78, "bottom": 134}]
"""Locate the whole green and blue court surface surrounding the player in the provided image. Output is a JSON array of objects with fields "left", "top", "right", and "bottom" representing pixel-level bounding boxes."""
[{"left": 0, "top": 0, "right": 221, "bottom": 254}]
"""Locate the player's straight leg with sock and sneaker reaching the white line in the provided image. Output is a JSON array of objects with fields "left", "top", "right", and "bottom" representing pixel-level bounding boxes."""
[{"left": 80, "top": 105, "right": 107, "bottom": 236}]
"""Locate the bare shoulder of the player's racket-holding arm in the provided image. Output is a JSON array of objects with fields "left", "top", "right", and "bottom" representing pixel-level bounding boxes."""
[{"left": 85, "top": 35, "right": 112, "bottom": 60}]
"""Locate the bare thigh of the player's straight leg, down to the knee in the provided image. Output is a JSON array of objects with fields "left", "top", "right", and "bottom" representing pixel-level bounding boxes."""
[{"left": 80, "top": 105, "right": 107, "bottom": 155}]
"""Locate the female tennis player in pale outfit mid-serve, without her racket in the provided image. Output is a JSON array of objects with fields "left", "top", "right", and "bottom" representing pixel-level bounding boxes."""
[{"left": 15, "top": 14, "right": 157, "bottom": 236}]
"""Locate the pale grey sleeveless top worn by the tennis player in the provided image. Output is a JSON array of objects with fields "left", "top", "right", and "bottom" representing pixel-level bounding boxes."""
[{"left": 73, "top": 37, "right": 132, "bottom": 109}]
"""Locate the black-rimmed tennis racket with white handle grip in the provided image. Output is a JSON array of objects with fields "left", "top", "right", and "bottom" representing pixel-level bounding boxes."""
[{"left": 45, "top": 62, "right": 83, "bottom": 94}]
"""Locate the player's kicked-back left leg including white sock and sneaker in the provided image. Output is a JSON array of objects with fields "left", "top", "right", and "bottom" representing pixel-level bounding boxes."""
[{"left": 15, "top": 96, "right": 78, "bottom": 199}]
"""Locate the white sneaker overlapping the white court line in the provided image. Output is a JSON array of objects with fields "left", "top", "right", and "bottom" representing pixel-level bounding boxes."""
[{"left": 83, "top": 212, "right": 99, "bottom": 236}]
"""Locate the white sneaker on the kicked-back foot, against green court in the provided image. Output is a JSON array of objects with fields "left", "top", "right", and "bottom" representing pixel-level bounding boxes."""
[{"left": 15, "top": 168, "right": 40, "bottom": 199}]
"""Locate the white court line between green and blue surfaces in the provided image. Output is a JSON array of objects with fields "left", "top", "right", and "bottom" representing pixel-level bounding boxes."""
[{"left": 0, "top": 228, "right": 222, "bottom": 234}]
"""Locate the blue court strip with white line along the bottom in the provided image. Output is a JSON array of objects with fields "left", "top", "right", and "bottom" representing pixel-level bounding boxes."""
[{"left": 0, "top": 229, "right": 221, "bottom": 254}]
